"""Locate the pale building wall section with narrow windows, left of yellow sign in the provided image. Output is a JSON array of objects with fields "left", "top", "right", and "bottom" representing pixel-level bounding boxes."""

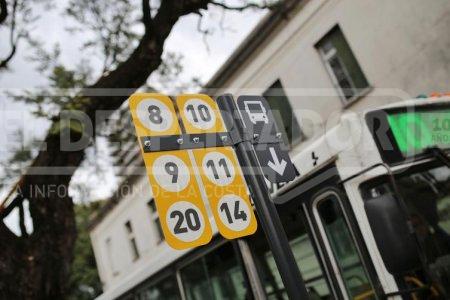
[{"left": 91, "top": 177, "right": 158, "bottom": 290}]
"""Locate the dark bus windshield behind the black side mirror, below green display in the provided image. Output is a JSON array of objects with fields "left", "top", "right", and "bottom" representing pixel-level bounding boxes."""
[{"left": 363, "top": 166, "right": 450, "bottom": 299}]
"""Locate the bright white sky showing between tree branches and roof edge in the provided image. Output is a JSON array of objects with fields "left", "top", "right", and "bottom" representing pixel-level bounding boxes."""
[{"left": 0, "top": 0, "right": 266, "bottom": 88}]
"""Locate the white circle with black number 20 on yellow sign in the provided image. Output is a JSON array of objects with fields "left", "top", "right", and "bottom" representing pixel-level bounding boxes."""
[{"left": 166, "top": 201, "right": 205, "bottom": 242}]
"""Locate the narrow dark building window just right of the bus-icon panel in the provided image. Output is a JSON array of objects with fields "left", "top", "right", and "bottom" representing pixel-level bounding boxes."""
[{"left": 263, "top": 80, "right": 304, "bottom": 145}]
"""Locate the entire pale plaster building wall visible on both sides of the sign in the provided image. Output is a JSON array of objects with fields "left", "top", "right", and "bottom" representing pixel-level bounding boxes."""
[{"left": 91, "top": 0, "right": 450, "bottom": 291}]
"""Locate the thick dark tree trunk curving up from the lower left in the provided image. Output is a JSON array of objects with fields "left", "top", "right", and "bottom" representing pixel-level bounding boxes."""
[{"left": 0, "top": 0, "right": 210, "bottom": 299}]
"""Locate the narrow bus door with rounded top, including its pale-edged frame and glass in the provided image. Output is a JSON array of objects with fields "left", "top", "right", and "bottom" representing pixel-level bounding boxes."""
[{"left": 307, "top": 187, "right": 382, "bottom": 300}]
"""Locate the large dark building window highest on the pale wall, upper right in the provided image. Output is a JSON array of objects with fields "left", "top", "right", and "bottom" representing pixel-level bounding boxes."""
[{"left": 316, "top": 26, "right": 369, "bottom": 103}]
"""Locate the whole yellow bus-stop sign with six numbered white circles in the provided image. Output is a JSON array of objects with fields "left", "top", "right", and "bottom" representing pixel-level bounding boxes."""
[{"left": 129, "top": 94, "right": 257, "bottom": 249}]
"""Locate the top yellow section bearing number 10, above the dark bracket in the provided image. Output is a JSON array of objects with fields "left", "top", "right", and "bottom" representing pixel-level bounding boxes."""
[{"left": 177, "top": 94, "right": 227, "bottom": 134}]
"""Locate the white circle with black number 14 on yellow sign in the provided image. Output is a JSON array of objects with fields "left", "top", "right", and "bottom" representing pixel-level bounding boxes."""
[{"left": 217, "top": 194, "right": 251, "bottom": 231}]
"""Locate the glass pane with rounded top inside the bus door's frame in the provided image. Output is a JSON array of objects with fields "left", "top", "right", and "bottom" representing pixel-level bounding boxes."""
[{"left": 317, "top": 193, "right": 374, "bottom": 299}]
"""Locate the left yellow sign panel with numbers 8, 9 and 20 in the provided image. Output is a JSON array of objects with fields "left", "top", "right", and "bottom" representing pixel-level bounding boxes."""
[{"left": 129, "top": 94, "right": 212, "bottom": 249}]
